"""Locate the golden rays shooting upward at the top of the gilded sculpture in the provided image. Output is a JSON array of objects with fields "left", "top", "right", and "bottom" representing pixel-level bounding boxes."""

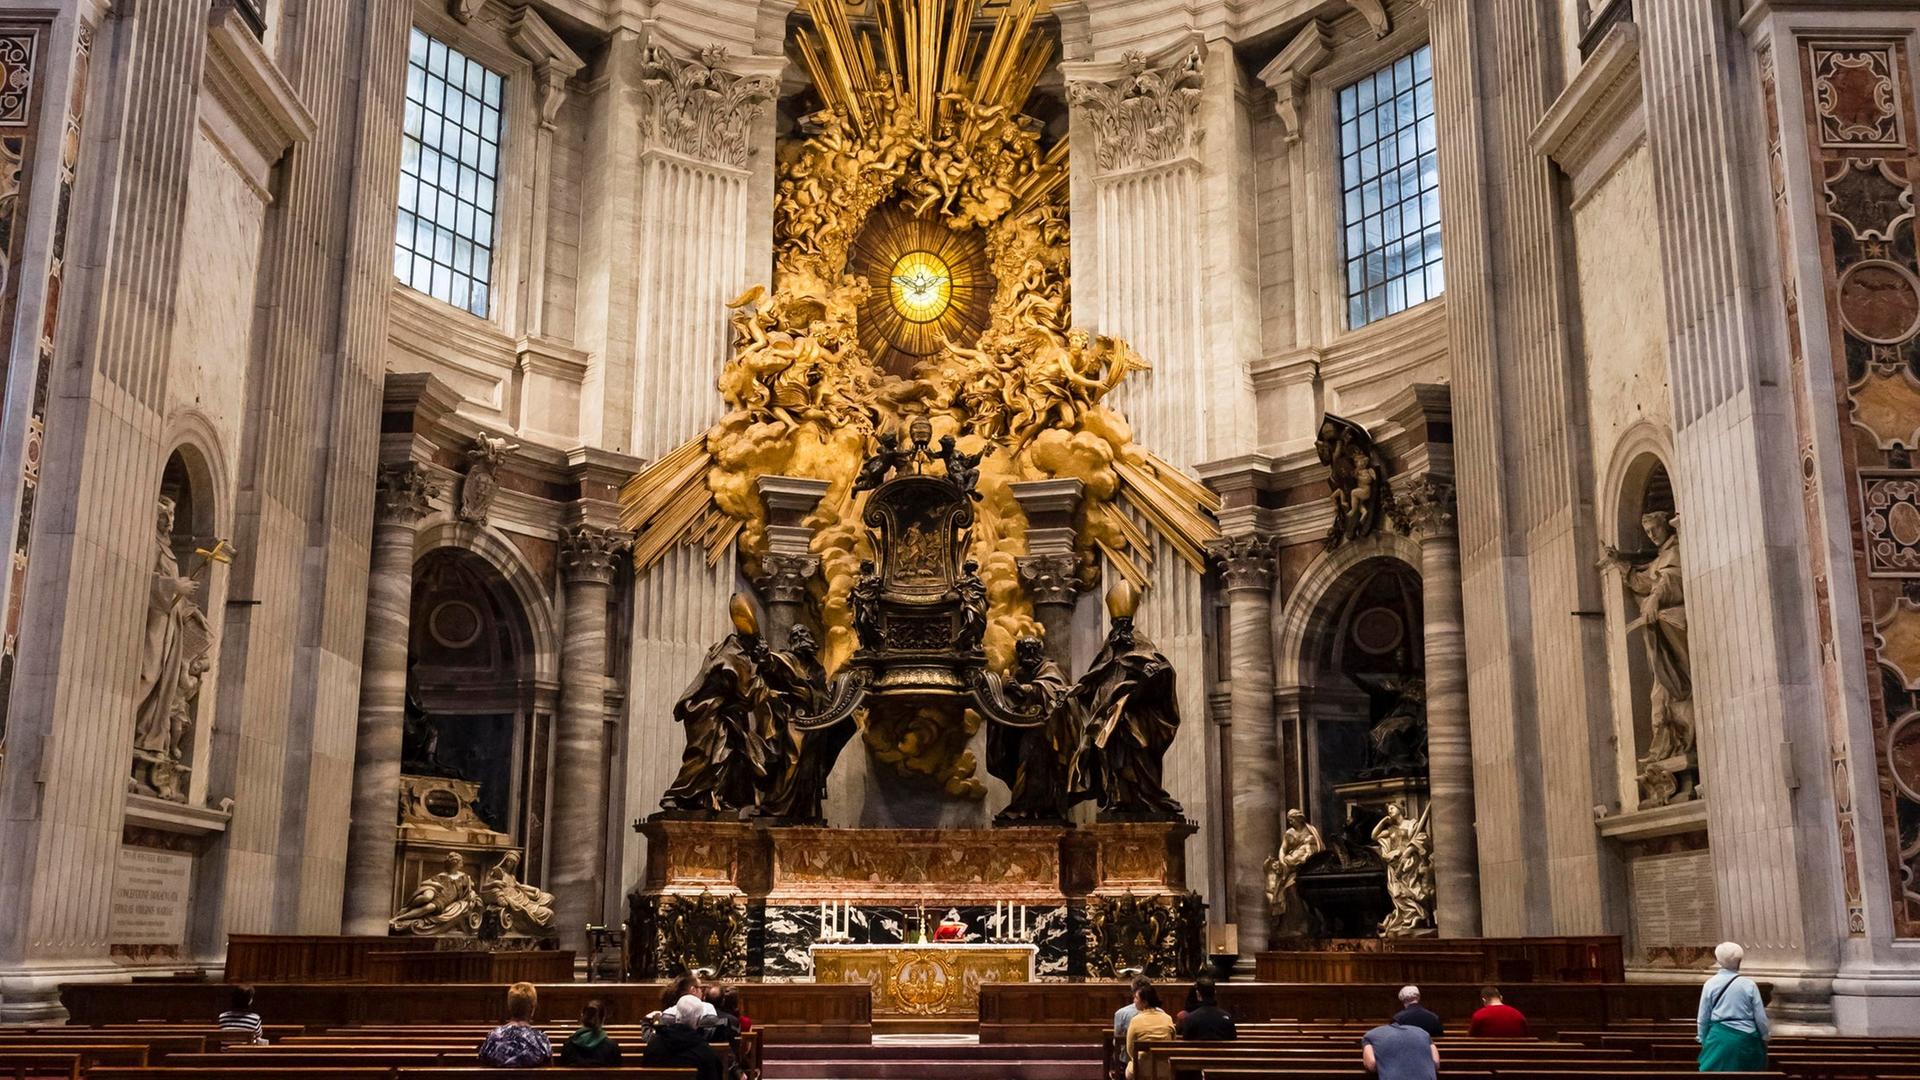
[{"left": 795, "top": 0, "right": 1054, "bottom": 142}]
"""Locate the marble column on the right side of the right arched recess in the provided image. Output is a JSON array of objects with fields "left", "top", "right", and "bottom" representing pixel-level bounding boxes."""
[{"left": 1402, "top": 477, "right": 1480, "bottom": 938}]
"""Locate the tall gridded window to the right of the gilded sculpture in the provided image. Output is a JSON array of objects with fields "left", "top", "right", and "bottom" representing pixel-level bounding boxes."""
[{"left": 1338, "top": 44, "right": 1446, "bottom": 329}]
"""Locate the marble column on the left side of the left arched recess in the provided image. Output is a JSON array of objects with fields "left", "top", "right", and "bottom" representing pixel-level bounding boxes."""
[{"left": 340, "top": 461, "right": 440, "bottom": 934}]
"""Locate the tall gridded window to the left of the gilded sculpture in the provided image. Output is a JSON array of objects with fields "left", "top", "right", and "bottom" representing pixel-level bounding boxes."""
[{"left": 394, "top": 29, "right": 501, "bottom": 317}]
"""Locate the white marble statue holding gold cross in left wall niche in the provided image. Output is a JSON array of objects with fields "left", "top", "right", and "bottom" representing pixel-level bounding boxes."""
[{"left": 132, "top": 496, "right": 225, "bottom": 801}]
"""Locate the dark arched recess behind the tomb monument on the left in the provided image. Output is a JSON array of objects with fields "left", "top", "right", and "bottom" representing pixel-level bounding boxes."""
[{"left": 401, "top": 548, "right": 545, "bottom": 860}]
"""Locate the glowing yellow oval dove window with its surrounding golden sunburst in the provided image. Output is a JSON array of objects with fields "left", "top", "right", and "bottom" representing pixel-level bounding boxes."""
[{"left": 847, "top": 204, "right": 993, "bottom": 377}]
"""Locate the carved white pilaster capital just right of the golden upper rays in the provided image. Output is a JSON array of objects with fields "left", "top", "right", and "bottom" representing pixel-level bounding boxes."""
[{"left": 1068, "top": 46, "right": 1200, "bottom": 171}]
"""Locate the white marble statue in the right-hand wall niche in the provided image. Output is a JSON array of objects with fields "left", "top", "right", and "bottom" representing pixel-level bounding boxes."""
[{"left": 1601, "top": 511, "right": 1699, "bottom": 809}]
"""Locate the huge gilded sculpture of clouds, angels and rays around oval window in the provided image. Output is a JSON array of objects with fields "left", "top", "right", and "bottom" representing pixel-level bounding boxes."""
[{"left": 622, "top": 0, "right": 1219, "bottom": 669}]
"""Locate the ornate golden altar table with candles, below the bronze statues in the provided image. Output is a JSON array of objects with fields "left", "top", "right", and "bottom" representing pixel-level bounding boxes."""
[{"left": 808, "top": 944, "right": 1039, "bottom": 1017}]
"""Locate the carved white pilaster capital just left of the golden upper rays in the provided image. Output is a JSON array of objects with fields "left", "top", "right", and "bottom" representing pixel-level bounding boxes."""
[{"left": 639, "top": 44, "right": 778, "bottom": 167}]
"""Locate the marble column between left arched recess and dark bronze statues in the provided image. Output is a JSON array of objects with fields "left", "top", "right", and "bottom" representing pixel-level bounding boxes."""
[{"left": 547, "top": 525, "right": 634, "bottom": 955}]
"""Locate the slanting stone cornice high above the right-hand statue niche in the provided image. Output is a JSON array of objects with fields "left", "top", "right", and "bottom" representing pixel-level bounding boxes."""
[{"left": 1528, "top": 23, "right": 1645, "bottom": 202}]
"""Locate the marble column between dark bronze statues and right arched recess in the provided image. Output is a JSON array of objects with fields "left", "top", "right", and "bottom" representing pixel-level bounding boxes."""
[{"left": 1210, "top": 534, "right": 1286, "bottom": 955}]
